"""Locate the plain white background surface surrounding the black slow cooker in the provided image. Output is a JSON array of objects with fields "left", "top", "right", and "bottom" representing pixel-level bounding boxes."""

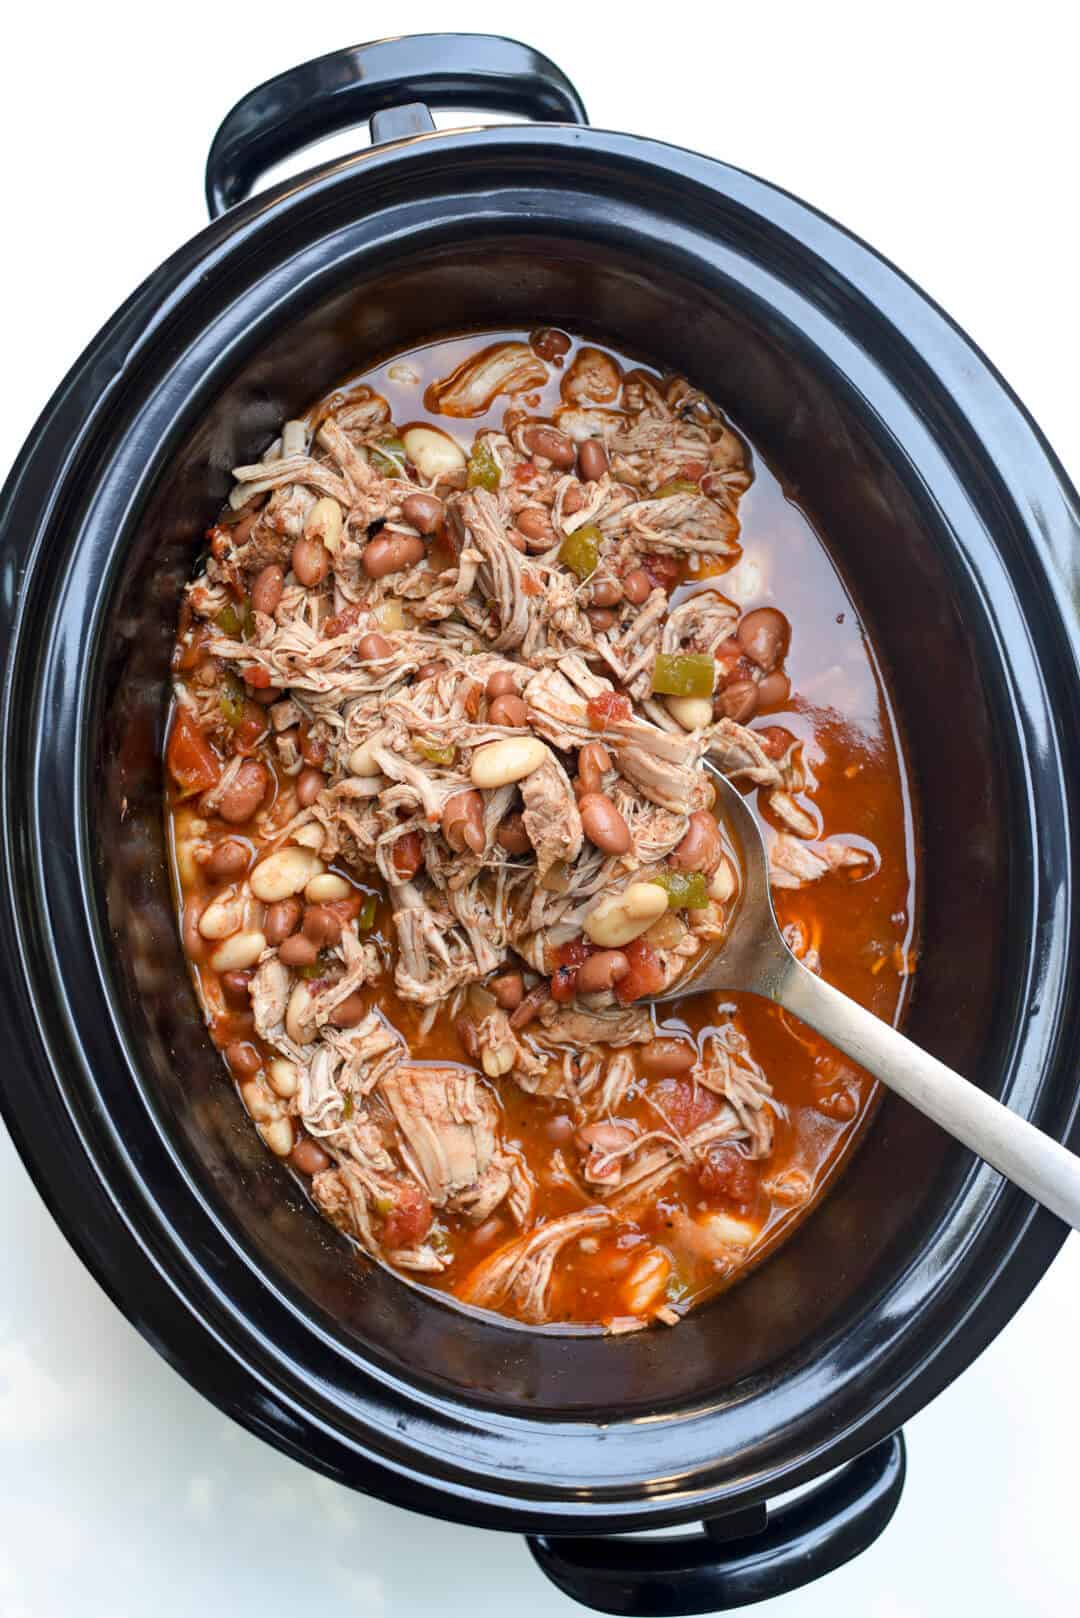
[{"left": 0, "top": 0, "right": 1080, "bottom": 1618}]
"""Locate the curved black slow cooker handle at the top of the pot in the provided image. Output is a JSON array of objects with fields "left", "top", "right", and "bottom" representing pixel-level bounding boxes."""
[{"left": 206, "top": 34, "right": 588, "bottom": 218}]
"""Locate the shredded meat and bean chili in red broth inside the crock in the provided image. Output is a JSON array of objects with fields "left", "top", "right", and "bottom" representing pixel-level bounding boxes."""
[{"left": 165, "top": 328, "right": 915, "bottom": 1330}]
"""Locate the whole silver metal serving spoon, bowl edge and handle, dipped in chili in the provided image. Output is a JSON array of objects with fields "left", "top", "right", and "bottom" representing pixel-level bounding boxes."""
[{"left": 653, "top": 764, "right": 1080, "bottom": 1230}]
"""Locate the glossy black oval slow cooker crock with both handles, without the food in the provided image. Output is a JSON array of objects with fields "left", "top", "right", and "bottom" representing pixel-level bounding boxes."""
[{"left": 0, "top": 36, "right": 1080, "bottom": 1613}]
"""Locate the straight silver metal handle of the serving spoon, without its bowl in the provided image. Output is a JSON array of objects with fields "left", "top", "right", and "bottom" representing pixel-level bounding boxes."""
[{"left": 774, "top": 959, "right": 1080, "bottom": 1230}]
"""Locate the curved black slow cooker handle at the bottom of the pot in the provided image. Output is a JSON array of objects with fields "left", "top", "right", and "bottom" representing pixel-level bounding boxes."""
[{"left": 528, "top": 1432, "right": 907, "bottom": 1618}]
